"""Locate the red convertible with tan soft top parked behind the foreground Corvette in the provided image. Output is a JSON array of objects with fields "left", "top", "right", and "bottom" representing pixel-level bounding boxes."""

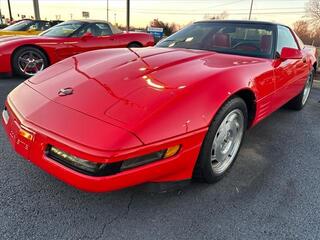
[{"left": 0, "top": 20, "right": 154, "bottom": 77}]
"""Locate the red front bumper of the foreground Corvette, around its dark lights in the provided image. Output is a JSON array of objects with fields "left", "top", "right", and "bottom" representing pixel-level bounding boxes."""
[{"left": 2, "top": 100, "right": 207, "bottom": 192}]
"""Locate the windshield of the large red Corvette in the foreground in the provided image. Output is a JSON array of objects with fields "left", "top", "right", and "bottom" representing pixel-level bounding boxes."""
[{"left": 157, "top": 22, "right": 275, "bottom": 58}]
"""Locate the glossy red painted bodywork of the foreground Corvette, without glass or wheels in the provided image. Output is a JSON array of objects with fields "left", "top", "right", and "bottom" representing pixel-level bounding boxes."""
[{"left": 3, "top": 25, "right": 314, "bottom": 191}]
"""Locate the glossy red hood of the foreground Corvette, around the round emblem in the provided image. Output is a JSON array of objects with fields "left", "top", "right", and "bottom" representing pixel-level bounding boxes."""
[{"left": 26, "top": 48, "right": 259, "bottom": 142}]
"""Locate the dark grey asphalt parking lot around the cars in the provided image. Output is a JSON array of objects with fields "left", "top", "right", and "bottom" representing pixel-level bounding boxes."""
[{"left": 0, "top": 79, "right": 320, "bottom": 240}]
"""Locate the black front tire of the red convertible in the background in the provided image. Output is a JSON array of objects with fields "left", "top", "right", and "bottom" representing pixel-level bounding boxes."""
[{"left": 12, "top": 47, "right": 49, "bottom": 78}]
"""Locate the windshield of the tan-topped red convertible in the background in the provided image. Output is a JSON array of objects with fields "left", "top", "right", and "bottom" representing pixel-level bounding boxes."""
[{"left": 40, "top": 22, "right": 83, "bottom": 37}]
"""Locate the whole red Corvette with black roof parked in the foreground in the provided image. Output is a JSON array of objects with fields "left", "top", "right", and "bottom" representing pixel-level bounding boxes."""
[{"left": 2, "top": 21, "right": 317, "bottom": 192}]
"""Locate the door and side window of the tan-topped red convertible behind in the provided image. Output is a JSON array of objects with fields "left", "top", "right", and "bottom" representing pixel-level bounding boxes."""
[{"left": 72, "top": 22, "right": 119, "bottom": 53}]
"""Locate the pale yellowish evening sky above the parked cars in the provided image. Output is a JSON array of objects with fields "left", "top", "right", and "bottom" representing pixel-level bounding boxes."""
[{"left": 0, "top": 0, "right": 308, "bottom": 27}]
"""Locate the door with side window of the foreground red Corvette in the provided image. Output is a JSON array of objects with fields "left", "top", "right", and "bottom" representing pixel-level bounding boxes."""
[{"left": 274, "top": 25, "right": 308, "bottom": 109}]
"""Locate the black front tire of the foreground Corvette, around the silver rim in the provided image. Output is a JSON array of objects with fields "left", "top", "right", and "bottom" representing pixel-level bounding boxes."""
[{"left": 194, "top": 97, "right": 248, "bottom": 183}]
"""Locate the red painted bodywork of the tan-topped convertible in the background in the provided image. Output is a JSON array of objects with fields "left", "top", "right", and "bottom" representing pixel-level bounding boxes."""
[{"left": 0, "top": 32, "right": 154, "bottom": 73}]
